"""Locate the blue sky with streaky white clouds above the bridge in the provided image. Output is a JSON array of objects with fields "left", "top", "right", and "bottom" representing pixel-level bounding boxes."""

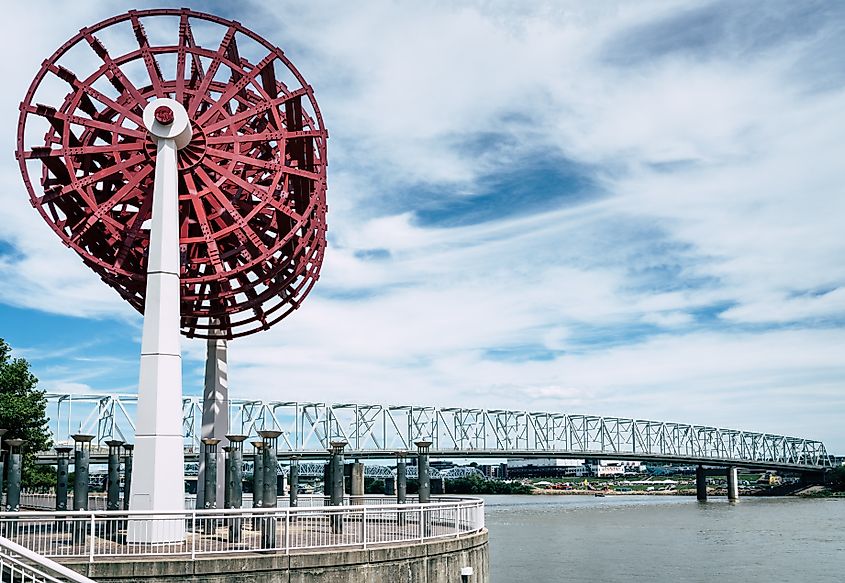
[{"left": 0, "top": 1, "right": 845, "bottom": 453}]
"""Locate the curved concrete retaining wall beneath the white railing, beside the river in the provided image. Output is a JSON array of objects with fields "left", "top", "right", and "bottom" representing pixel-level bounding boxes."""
[{"left": 62, "top": 530, "right": 490, "bottom": 583}]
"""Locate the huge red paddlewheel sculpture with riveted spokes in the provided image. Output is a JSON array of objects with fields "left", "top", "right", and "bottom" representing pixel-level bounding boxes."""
[{"left": 17, "top": 9, "right": 328, "bottom": 338}]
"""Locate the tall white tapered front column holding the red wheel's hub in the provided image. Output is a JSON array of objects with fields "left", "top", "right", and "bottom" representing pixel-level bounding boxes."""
[{"left": 127, "top": 99, "right": 191, "bottom": 543}]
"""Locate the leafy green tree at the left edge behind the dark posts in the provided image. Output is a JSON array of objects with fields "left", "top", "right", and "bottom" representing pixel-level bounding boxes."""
[{"left": 0, "top": 338, "right": 53, "bottom": 488}]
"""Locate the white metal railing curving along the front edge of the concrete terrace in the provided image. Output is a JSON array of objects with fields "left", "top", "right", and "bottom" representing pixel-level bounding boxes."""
[{"left": 0, "top": 497, "right": 484, "bottom": 562}]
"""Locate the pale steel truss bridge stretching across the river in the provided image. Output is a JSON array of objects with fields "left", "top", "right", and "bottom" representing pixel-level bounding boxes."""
[{"left": 41, "top": 394, "right": 831, "bottom": 472}]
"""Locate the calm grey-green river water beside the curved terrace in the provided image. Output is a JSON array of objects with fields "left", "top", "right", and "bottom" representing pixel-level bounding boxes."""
[{"left": 484, "top": 496, "right": 845, "bottom": 583}]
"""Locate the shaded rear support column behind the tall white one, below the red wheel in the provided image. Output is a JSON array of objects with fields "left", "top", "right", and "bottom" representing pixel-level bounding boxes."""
[{"left": 197, "top": 320, "right": 229, "bottom": 508}]
